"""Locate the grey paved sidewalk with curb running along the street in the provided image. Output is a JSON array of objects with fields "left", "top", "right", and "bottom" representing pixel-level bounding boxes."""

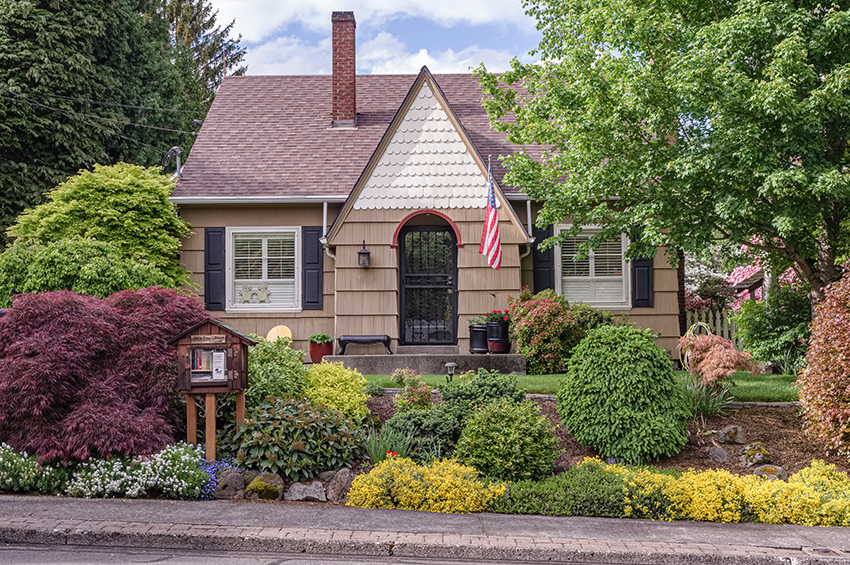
[{"left": 0, "top": 495, "right": 850, "bottom": 565}]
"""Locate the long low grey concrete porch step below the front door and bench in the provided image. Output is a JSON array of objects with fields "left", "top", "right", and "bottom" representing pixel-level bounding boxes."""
[{"left": 325, "top": 353, "right": 526, "bottom": 375}]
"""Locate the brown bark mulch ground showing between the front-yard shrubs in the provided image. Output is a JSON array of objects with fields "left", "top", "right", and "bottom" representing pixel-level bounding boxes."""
[{"left": 367, "top": 396, "right": 850, "bottom": 475}]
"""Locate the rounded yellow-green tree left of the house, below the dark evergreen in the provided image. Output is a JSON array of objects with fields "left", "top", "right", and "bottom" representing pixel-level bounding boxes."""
[{"left": 9, "top": 163, "right": 190, "bottom": 284}]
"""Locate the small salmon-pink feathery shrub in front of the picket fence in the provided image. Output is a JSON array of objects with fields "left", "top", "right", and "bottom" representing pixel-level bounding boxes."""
[{"left": 679, "top": 335, "right": 761, "bottom": 385}]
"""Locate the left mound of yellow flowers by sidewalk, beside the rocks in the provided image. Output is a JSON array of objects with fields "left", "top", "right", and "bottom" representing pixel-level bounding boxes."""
[{"left": 347, "top": 457, "right": 505, "bottom": 513}]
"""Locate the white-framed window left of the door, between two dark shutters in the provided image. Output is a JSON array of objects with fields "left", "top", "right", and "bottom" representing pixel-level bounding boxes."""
[{"left": 227, "top": 228, "right": 301, "bottom": 311}]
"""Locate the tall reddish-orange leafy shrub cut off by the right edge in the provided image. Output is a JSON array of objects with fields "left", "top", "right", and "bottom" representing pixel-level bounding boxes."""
[{"left": 797, "top": 274, "right": 850, "bottom": 453}]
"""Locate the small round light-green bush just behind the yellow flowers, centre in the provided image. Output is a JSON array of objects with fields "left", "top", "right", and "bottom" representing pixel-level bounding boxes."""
[{"left": 455, "top": 398, "right": 558, "bottom": 481}]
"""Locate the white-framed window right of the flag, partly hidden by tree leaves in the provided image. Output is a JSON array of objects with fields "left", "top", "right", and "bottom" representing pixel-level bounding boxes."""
[{"left": 555, "top": 226, "right": 631, "bottom": 310}]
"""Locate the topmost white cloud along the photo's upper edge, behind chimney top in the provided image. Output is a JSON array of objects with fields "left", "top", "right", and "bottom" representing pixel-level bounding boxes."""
[{"left": 212, "top": 0, "right": 534, "bottom": 43}]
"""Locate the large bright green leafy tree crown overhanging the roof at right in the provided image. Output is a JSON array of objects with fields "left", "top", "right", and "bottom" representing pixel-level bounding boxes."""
[{"left": 477, "top": 0, "right": 850, "bottom": 303}]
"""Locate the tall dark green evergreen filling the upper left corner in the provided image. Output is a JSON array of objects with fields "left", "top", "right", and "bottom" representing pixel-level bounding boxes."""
[{"left": 0, "top": 0, "right": 208, "bottom": 247}]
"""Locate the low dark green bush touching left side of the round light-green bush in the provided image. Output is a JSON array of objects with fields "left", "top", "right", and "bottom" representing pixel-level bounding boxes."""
[{"left": 381, "top": 404, "right": 461, "bottom": 462}]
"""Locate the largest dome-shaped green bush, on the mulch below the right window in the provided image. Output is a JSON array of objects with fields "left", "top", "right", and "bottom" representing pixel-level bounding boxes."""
[{"left": 557, "top": 326, "right": 688, "bottom": 463}]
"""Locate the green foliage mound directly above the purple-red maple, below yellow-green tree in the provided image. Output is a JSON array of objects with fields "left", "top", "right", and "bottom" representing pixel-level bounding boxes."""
[{"left": 0, "top": 239, "right": 174, "bottom": 308}]
